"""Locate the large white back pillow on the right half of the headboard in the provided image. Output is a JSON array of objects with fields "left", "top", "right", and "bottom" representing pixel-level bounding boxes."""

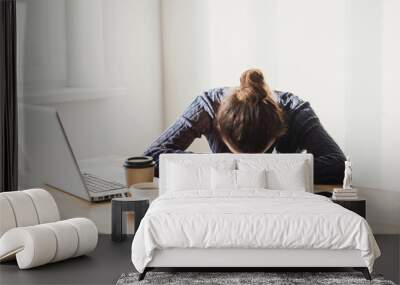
[{"left": 238, "top": 159, "right": 311, "bottom": 191}]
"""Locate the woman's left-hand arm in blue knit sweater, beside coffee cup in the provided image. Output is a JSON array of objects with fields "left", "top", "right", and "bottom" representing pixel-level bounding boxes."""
[{"left": 144, "top": 92, "right": 212, "bottom": 177}]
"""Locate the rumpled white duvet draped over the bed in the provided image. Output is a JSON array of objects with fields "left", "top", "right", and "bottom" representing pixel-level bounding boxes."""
[{"left": 132, "top": 189, "right": 380, "bottom": 272}]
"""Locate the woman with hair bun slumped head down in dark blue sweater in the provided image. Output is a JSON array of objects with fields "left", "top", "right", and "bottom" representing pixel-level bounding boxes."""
[{"left": 144, "top": 69, "right": 345, "bottom": 184}]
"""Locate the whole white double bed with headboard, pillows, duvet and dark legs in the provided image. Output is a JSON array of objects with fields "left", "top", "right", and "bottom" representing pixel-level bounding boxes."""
[{"left": 132, "top": 154, "right": 380, "bottom": 280}]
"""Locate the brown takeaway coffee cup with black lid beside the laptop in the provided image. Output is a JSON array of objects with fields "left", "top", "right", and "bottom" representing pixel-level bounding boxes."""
[{"left": 124, "top": 156, "right": 155, "bottom": 187}]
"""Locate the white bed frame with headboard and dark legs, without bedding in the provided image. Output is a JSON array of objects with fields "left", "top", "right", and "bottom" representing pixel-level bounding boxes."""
[{"left": 139, "top": 154, "right": 371, "bottom": 280}]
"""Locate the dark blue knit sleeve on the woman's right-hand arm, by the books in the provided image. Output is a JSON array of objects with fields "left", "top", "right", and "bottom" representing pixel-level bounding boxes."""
[{"left": 294, "top": 102, "right": 346, "bottom": 184}]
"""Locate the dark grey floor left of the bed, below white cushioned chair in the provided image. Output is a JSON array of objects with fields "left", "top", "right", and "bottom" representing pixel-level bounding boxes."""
[{"left": 0, "top": 235, "right": 134, "bottom": 285}]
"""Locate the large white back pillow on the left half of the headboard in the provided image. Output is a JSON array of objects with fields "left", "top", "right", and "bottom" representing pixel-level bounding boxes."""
[{"left": 167, "top": 160, "right": 235, "bottom": 191}]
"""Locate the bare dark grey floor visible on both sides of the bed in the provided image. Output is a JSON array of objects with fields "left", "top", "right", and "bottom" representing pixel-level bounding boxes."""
[{"left": 0, "top": 235, "right": 400, "bottom": 285}]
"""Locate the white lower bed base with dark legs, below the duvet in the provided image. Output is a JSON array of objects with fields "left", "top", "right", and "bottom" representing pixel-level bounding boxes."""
[{"left": 139, "top": 248, "right": 371, "bottom": 280}]
